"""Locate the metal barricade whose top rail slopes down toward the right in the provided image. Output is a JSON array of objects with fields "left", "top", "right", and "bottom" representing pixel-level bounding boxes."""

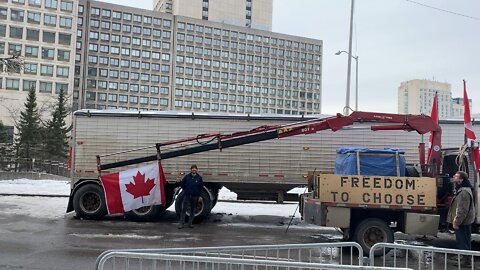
[{"left": 96, "top": 251, "right": 407, "bottom": 270}]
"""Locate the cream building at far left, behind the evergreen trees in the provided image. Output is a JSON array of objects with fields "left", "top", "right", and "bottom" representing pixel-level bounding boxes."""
[{"left": 0, "top": 0, "right": 77, "bottom": 132}]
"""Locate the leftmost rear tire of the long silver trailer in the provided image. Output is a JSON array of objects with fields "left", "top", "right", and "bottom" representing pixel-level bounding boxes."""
[{"left": 73, "top": 183, "right": 108, "bottom": 219}]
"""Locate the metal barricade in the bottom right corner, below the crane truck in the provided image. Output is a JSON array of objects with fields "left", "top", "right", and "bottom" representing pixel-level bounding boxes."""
[{"left": 369, "top": 243, "right": 480, "bottom": 270}]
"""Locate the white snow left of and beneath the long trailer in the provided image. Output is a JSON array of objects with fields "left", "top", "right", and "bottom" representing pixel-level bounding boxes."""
[{"left": 0, "top": 179, "right": 299, "bottom": 218}]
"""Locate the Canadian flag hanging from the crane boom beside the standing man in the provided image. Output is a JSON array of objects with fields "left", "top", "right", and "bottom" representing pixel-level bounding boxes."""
[{"left": 100, "top": 161, "right": 165, "bottom": 214}]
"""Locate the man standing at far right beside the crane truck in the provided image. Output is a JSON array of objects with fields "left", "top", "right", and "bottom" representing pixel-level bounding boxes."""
[{"left": 447, "top": 171, "right": 475, "bottom": 250}]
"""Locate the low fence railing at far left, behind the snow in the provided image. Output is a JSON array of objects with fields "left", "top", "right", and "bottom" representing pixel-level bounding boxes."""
[{"left": 0, "top": 158, "right": 70, "bottom": 177}]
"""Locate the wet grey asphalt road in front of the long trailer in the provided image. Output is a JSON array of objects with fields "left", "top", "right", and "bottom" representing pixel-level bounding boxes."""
[{"left": 0, "top": 202, "right": 340, "bottom": 269}]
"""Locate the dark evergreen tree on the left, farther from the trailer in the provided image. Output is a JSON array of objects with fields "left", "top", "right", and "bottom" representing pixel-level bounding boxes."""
[{"left": 17, "top": 87, "right": 41, "bottom": 158}]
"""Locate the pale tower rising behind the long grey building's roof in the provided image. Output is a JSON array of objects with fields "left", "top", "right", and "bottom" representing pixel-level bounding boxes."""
[{"left": 153, "top": 0, "right": 273, "bottom": 31}]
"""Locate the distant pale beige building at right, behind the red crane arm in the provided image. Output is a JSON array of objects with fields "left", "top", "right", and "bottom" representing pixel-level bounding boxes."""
[{"left": 398, "top": 80, "right": 472, "bottom": 118}]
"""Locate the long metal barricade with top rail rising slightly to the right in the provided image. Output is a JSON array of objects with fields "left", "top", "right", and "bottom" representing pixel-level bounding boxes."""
[{"left": 96, "top": 242, "right": 372, "bottom": 269}]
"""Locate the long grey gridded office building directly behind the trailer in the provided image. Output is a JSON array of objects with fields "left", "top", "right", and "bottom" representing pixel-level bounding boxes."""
[{"left": 73, "top": 0, "right": 323, "bottom": 114}]
